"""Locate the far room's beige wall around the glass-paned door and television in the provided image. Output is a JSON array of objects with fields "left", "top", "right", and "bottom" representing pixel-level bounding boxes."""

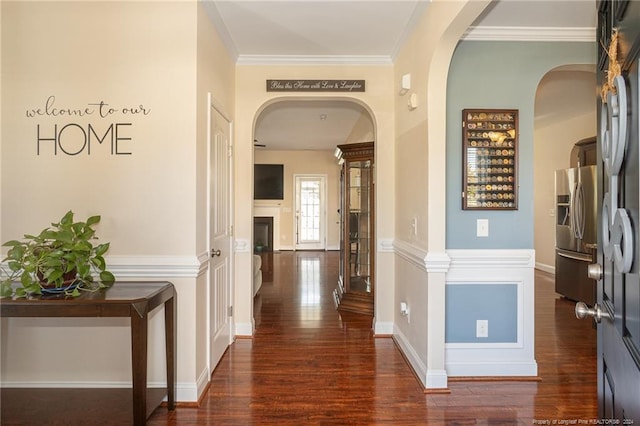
[{"left": 254, "top": 149, "right": 340, "bottom": 250}]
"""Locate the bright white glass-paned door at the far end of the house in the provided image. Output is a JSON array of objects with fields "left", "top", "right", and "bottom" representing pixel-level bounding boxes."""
[{"left": 294, "top": 175, "right": 327, "bottom": 250}]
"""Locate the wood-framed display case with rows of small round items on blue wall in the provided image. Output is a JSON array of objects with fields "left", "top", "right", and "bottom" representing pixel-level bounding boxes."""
[{"left": 462, "top": 109, "right": 518, "bottom": 210}]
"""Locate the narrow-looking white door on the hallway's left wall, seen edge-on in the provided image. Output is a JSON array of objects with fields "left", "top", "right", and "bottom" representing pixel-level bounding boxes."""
[{"left": 209, "top": 97, "right": 232, "bottom": 371}]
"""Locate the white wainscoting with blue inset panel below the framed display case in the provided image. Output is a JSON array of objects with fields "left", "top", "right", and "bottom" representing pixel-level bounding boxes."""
[{"left": 445, "top": 250, "right": 538, "bottom": 377}]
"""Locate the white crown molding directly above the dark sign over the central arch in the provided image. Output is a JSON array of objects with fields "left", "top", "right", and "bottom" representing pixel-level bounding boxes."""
[{"left": 236, "top": 55, "right": 393, "bottom": 65}]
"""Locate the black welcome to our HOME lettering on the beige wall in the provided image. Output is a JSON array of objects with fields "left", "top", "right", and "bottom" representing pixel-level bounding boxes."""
[{"left": 26, "top": 96, "right": 151, "bottom": 155}]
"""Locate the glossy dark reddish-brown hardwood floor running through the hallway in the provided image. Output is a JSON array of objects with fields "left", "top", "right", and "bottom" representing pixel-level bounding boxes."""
[{"left": 149, "top": 252, "right": 597, "bottom": 425}]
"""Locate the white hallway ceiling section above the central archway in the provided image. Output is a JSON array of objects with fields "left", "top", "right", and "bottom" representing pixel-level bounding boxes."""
[{"left": 202, "top": 0, "right": 428, "bottom": 63}]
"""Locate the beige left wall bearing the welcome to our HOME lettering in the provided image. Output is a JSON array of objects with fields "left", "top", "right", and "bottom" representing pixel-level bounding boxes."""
[{"left": 0, "top": 2, "right": 234, "bottom": 400}]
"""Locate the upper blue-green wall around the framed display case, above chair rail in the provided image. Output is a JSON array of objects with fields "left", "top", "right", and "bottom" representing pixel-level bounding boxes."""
[{"left": 446, "top": 41, "right": 596, "bottom": 248}]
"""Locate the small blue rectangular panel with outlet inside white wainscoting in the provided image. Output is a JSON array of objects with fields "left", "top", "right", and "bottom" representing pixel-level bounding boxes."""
[{"left": 445, "top": 283, "right": 518, "bottom": 343}]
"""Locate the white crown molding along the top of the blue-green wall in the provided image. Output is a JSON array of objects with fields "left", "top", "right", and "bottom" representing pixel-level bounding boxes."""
[{"left": 462, "top": 26, "right": 596, "bottom": 43}]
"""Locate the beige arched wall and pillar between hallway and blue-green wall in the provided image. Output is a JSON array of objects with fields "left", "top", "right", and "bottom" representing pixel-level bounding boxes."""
[{"left": 393, "top": 1, "right": 489, "bottom": 388}]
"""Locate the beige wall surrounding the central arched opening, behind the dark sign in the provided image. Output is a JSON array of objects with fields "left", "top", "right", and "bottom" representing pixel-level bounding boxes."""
[{"left": 234, "top": 65, "right": 394, "bottom": 335}]
